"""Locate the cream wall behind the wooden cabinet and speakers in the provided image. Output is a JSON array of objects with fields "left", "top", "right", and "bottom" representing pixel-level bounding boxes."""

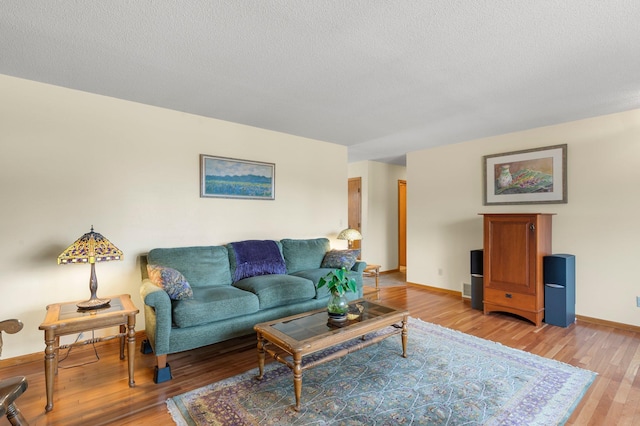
[{"left": 407, "top": 110, "right": 640, "bottom": 326}]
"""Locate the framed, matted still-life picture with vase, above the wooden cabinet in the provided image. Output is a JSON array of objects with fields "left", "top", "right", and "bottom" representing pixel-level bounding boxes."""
[{"left": 483, "top": 144, "right": 567, "bottom": 206}]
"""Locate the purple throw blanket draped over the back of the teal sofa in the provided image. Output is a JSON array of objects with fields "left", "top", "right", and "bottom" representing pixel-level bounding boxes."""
[{"left": 231, "top": 240, "right": 287, "bottom": 282}]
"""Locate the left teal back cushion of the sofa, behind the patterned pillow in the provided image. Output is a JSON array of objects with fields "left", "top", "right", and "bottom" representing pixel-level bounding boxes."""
[{"left": 147, "top": 246, "right": 231, "bottom": 288}]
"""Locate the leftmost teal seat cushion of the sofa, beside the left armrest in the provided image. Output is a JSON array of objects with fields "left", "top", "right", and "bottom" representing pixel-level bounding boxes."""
[{"left": 173, "top": 286, "right": 259, "bottom": 328}]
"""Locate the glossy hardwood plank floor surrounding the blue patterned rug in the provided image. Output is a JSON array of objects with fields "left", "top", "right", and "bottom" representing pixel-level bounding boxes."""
[{"left": 0, "top": 274, "right": 640, "bottom": 426}]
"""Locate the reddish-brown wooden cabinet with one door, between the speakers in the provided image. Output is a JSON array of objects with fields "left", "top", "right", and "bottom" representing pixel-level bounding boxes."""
[{"left": 483, "top": 213, "right": 553, "bottom": 326}]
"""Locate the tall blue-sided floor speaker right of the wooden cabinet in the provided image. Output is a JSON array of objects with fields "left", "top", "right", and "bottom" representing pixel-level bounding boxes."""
[{"left": 543, "top": 254, "right": 576, "bottom": 327}]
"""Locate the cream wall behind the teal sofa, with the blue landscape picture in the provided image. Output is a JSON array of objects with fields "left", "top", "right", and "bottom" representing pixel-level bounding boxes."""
[{"left": 0, "top": 75, "right": 347, "bottom": 358}]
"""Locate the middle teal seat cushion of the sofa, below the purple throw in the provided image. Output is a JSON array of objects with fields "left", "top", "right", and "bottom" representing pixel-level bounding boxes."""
[{"left": 233, "top": 275, "right": 316, "bottom": 310}]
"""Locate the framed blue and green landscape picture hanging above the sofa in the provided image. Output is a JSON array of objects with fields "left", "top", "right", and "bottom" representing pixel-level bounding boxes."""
[{"left": 200, "top": 154, "right": 276, "bottom": 200}]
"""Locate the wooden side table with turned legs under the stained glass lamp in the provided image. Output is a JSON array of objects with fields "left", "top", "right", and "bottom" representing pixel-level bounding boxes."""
[{"left": 39, "top": 294, "right": 140, "bottom": 412}]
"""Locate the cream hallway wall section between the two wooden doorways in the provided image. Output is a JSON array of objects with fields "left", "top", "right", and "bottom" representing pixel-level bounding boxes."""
[{"left": 348, "top": 161, "right": 406, "bottom": 271}]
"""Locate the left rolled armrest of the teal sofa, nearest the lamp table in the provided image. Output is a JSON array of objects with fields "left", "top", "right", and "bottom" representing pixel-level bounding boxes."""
[{"left": 140, "top": 278, "right": 172, "bottom": 356}]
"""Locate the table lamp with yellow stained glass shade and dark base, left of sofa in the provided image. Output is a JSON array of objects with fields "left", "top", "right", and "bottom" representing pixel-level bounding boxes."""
[{"left": 58, "top": 226, "right": 122, "bottom": 309}]
